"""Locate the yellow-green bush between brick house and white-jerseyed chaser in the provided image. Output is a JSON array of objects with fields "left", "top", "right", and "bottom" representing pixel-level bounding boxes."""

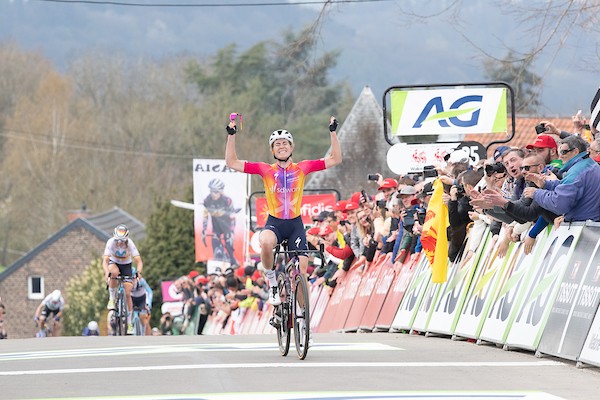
[{"left": 62, "top": 259, "right": 108, "bottom": 336}]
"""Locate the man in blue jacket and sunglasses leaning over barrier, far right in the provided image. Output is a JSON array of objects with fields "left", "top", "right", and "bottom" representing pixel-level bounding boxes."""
[{"left": 524, "top": 135, "right": 600, "bottom": 222}]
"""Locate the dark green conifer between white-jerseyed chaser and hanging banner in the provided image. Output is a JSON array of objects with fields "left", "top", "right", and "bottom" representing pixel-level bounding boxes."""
[{"left": 140, "top": 189, "right": 195, "bottom": 325}]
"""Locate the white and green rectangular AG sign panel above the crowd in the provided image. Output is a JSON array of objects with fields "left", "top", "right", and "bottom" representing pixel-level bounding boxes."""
[{"left": 390, "top": 88, "right": 507, "bottom": 136}]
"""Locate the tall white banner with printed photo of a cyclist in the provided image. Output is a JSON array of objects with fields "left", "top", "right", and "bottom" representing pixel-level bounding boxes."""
[{"left": 193, "top": 159, "right": 248, "bottom": 274}]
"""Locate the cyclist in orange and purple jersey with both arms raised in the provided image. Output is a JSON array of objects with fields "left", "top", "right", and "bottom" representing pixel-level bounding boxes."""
[{"left": 225, "top": 116, "right": 342, "bottom": 306}]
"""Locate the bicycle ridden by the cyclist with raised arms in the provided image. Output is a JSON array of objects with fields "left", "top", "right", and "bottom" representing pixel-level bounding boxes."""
[{"left": 270, "top": 242, "right": 324, "bottom": 360}]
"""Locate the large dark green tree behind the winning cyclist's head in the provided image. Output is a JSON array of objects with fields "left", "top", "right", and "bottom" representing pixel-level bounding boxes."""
[{"left": 187, "top": 28, "right": 353, "bottom": 164}]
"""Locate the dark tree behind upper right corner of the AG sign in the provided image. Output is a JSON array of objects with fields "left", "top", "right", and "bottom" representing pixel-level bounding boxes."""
[{"left": 483, "top": 51, "right": 542, "bottom": 114}]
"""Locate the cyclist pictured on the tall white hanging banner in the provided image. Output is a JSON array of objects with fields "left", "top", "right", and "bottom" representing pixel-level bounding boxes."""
[{"left": 202, "top": 178, "right": 240, "bottom": 265}]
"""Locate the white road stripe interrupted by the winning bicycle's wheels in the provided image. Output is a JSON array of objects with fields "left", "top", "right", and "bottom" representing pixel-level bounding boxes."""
[{"left": 0, "top": 343, "right": 403, "bottom": 362}]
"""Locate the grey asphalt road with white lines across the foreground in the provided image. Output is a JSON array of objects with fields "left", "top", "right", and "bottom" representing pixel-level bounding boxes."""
[{"left": 0, "top": 333, "right": 600, "bottom": 400}]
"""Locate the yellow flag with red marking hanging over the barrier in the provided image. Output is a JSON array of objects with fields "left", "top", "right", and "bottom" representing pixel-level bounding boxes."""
[{"left": 421, "top": 178, "right": 450, "bottom": 283}]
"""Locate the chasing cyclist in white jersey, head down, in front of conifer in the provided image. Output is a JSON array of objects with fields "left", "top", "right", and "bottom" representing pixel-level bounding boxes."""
[{"left": 102, "top": 224, "right": 144, "bottom": 335}]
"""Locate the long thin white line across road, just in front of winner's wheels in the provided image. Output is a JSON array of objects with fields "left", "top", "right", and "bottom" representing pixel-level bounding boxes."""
[{"left": 0, "top": 361, "right": 562, "bottom": 376}]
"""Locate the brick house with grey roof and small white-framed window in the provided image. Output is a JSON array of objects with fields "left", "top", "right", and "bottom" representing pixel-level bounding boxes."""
[{"left": 0, "top": 207, "right": 145, "bottom": 338}]
